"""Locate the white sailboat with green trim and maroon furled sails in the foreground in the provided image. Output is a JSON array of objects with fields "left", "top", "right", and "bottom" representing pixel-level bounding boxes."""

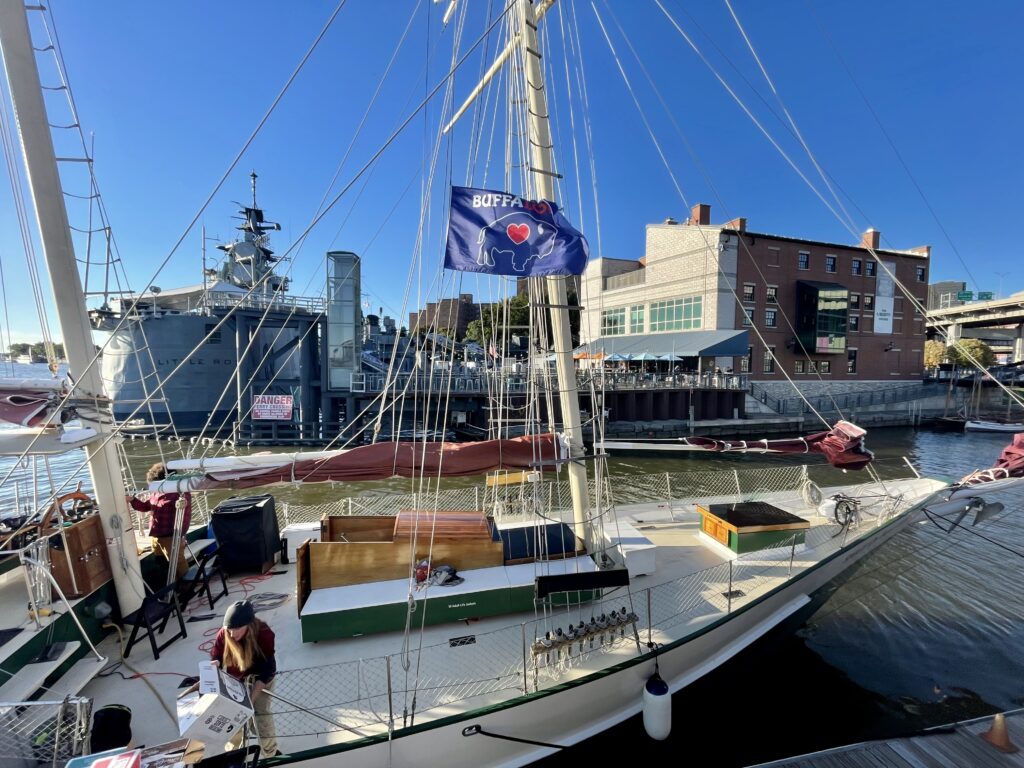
[{"left": 0, "top": 0, "right": 1024, "bottom": 766}]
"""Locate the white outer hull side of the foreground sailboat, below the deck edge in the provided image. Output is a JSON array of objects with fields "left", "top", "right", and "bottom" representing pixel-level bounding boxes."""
[{"left": 274, "top": 511, "right": 918, "bottom": 768}]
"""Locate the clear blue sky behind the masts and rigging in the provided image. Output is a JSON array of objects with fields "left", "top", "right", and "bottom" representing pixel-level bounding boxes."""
[{"left": 0, "top": 0, "right": 1024, "bottom": 340}]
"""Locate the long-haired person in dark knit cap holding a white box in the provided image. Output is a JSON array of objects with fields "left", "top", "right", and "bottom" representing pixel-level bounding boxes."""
[{"left": 210, "top": 600, "right": 281, "bottom": 757}]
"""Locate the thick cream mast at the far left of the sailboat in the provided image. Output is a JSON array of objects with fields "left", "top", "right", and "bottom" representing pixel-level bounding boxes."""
[{"left": 0, "top": 0, "right": 144, "bottom": 614}]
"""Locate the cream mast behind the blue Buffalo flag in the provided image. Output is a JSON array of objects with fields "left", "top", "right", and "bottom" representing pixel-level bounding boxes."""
[{"left": 518, "top": 0, "right": 592, "bottom": 545}]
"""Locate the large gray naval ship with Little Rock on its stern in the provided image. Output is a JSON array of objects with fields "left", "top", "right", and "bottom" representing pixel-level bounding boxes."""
[{"left": 91, "top": 173, "right": 327, "bottom": 438}]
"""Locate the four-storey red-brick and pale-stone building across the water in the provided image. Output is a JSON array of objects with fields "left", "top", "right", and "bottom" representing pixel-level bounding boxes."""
[{"left": 583, "top": 205, "right": 931, "bottom": 382}]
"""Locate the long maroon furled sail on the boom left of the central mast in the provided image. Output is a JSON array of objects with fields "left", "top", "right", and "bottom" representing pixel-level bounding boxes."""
[{"left": 150, "top": 434, "right": 563, "bottom": 492}]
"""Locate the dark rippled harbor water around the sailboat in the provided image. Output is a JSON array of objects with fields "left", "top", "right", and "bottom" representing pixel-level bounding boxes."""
[{"left": 0, "top": 365, "right": 1024, "bottom": 766}]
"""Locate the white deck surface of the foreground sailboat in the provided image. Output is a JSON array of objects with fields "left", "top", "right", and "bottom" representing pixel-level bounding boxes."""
[{"left": 6, "top": 479, "right": 939, "bottom": 753}]
